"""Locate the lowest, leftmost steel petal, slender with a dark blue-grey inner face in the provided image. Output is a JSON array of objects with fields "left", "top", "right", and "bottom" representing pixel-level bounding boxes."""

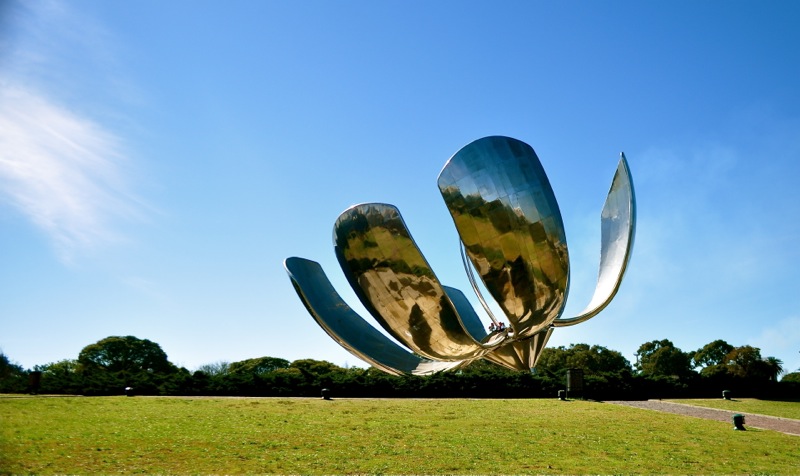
[{"left": 284, "top": 257, "right": 464, "bottom": 375}]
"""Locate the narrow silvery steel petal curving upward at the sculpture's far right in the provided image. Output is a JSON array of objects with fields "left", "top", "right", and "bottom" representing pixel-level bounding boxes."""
[{"left": 553, "top": 154, "right": 636, "bottom": 327}]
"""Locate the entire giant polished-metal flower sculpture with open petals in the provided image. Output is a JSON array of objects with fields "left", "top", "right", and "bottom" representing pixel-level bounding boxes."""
[{"left": 284, "top": 136, "right": 636, "bottom": 375}]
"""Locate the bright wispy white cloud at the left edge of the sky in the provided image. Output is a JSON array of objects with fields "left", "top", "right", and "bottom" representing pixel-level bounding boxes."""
[{"left": 0, "top": 85, "right": 140, "bottom": 259}]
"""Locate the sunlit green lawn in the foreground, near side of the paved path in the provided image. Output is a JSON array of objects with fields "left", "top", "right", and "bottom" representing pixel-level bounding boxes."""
[{"left": 0, "top": 397, "right": 800, "bottom": 474}]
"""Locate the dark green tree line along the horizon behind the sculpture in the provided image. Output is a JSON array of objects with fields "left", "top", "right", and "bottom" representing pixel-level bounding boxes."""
[{"left": 0, "top": 336, "right": 800, "bottom": 400}]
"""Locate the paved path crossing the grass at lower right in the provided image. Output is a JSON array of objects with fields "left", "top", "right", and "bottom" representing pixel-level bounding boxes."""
[{"left": 605, "top": 400, "right": 800, "bottom": 436}]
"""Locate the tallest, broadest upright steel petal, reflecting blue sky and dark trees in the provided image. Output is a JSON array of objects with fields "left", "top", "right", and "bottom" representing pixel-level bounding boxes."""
[{"left": 438, "top": 136, "right": 569, "bottom": 338}]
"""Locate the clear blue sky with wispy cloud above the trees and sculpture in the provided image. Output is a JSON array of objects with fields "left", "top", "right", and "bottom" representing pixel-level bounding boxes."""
[{"left": 0, "top": 0, "right": 800, "bottom": 371}]
